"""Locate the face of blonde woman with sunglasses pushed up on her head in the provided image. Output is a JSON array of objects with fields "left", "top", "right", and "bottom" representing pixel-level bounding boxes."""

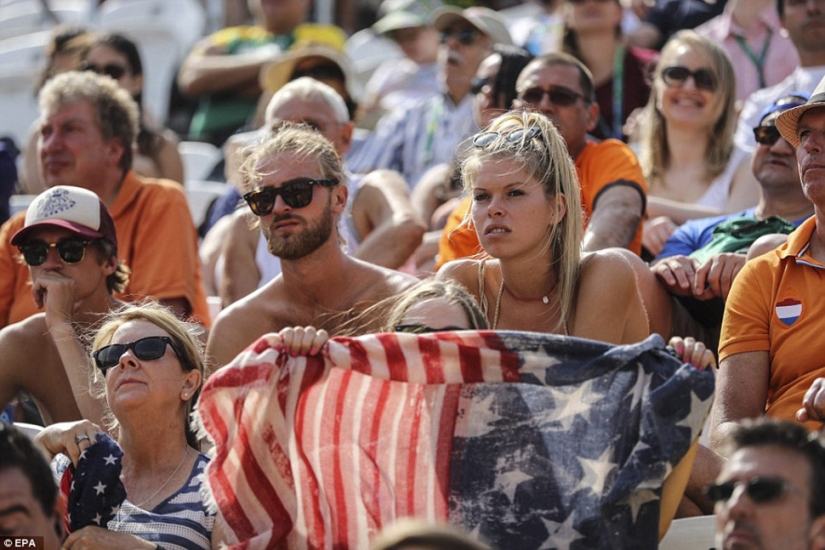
[{"left": 472, "top": 159, "right": 558, "bottom": 259}]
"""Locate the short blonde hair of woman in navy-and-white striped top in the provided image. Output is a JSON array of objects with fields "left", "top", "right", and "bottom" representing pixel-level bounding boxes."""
[{"left": 92, "top": 302, "right": 207, "bottom": 449}]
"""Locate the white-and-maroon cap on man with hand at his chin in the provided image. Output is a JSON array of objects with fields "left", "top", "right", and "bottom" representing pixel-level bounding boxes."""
[{"left": 11, "top": 185, "right": 117, "bottom": 252}]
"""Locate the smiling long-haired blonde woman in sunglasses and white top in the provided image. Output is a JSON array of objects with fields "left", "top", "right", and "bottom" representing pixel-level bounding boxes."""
[{"left": 639, "top": 31, "right": 759, "bottom": 257}]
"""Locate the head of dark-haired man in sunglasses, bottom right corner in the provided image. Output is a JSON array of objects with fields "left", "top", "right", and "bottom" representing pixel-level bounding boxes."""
[{"left": 707, "top": 419, "right": 825, "bottom": 550}]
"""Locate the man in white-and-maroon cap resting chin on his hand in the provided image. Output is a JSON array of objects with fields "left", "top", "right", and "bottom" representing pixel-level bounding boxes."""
[{"left": 0, "top": 186, "right": 129, "bottom": 423}]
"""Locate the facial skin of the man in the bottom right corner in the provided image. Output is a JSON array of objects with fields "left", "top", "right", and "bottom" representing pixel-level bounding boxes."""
[{"left": 715, "top": 445, "right": 812, "bottom": 550}]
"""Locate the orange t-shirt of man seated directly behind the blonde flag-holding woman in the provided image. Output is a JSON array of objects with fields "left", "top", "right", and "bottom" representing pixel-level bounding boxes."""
[{"left": 436, "top": 139, "right": 647, "bottom": 269}]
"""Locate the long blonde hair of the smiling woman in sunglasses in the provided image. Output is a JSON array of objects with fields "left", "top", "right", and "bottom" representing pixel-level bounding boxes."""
[{"left": 639, "top": 30, "right": 737, "bottom": 187}]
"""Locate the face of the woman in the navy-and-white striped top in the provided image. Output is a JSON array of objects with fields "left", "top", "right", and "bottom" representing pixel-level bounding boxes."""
[{"left": 106, "top": 321, "right": 192, "bottom": 418}]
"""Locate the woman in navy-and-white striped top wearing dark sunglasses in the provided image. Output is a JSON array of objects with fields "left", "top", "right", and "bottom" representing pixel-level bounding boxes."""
[{"left": 38, "top": 303, "right": 214, "bottom": 550}]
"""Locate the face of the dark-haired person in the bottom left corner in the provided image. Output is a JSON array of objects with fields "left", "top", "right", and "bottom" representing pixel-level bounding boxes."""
[{"left": 0, "top": 467, "right": 60, "bottom": 550}]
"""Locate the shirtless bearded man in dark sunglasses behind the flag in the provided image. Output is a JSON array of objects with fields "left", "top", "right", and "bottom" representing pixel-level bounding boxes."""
[{"left": 206, "top": 126, "right": 417, "bottom": 368}]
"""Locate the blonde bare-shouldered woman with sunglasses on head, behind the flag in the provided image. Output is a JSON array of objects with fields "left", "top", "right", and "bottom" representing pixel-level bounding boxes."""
[{"left": 437, "top": 112, "right": 648, "bottom": 344}]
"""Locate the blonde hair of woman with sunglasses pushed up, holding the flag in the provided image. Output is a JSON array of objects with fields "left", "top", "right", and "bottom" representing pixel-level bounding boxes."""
[{"left": 461, "top": 111, "right": 584, "bottom": 332}]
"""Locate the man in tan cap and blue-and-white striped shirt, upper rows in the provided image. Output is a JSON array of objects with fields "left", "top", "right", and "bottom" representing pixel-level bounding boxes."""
[{"left": 347, "top": 6, "right": 513, "bottom": 189}]
